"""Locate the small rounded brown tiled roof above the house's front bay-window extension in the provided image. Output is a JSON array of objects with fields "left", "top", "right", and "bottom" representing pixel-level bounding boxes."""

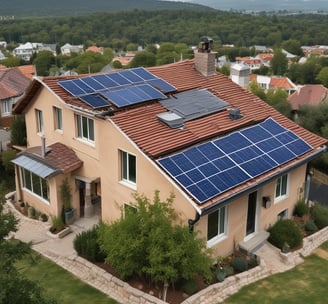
[{"left": 23, "top": 143, "right": 83, "bottom": 174}]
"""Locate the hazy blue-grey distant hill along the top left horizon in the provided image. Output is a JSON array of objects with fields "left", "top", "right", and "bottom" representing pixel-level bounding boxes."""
[{"left": 0, "top": 0, "right": 212, "bottom": 17}]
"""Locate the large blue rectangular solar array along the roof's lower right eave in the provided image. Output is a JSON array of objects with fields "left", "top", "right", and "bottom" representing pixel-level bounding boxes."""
[{"left": 158, "top": 118, "right": 312, "bottom": 203}]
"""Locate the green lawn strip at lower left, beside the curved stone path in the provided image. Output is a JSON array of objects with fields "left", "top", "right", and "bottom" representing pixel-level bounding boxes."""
[{"left": 17, "top": 253, "right": 117, "bottom": 304}]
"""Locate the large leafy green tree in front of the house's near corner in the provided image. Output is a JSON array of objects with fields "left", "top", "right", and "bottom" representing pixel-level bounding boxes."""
[{"left": 99, "top": 191, "right": 212, "bottom": 300}]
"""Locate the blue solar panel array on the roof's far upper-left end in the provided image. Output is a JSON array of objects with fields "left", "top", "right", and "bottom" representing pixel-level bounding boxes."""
[{"left": 58, "top": 68, "right": 176, "bottom": 109}]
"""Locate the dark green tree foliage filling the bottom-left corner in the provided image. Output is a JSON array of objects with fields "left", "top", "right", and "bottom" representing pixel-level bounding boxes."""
[{"left": 0, "top": 196, "right": 56, "bottom": 304}]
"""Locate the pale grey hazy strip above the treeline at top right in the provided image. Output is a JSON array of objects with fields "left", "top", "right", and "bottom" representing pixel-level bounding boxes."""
[{"left": 188, "top": 0, "right": 328, "bottom": 11}]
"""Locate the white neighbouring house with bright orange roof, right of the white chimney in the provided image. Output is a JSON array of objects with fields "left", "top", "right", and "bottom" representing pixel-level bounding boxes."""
[{"left": 249, "top": 74, "right": 297, "bottom": 95}]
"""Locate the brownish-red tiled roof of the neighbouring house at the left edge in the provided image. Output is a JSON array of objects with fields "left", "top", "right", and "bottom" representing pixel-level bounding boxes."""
[{"left": 0, "top": 68, "right": 31, "bottom": 99}]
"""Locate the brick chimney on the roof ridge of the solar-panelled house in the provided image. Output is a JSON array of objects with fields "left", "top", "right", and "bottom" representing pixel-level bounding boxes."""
[{"left": 195, "top": 37, "right": 217, "bottom": 76}]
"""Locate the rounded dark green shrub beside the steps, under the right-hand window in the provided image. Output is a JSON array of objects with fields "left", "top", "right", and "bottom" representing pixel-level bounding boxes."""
[{"left": 268, "top": 219, "right": 303, "bottom": 249}]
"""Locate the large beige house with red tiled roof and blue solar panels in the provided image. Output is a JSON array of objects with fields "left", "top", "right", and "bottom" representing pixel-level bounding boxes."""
[{"left": 13, "top": 41, "right": 327, "bottom": 256}]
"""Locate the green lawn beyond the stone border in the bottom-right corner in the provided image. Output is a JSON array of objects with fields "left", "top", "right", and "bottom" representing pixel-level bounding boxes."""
[{"left": 224, "top": 242, "right": 328, "bottom": 304}]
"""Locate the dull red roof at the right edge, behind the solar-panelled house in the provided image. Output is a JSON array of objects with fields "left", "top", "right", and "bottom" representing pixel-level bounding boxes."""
[{"left": 288, "top": 84, "right": 328, "bottom": 110}]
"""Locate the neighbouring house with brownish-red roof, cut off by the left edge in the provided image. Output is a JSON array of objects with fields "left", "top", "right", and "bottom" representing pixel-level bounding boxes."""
[{"left": 0, "top": 68, "right": 31, "bottom": 128}]
